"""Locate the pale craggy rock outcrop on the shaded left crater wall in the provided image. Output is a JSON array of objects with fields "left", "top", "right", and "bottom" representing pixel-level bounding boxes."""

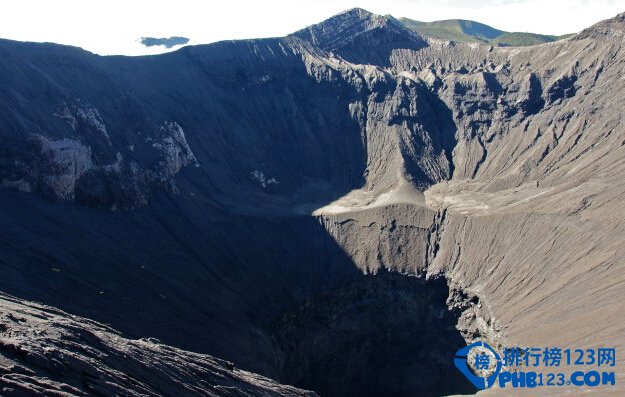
[{"left": 0, "top": 98, "right": 200, "bottom": 209}]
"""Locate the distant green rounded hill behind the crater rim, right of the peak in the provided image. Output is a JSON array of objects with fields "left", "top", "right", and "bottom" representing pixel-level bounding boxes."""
[{"left": 398, "top": 18, "right": 570, "bottom": 47}]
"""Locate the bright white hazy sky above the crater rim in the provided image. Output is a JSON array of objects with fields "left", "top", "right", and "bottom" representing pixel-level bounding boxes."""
[{"left": 0, "top": 0, "right": 625, "bottom": 55}]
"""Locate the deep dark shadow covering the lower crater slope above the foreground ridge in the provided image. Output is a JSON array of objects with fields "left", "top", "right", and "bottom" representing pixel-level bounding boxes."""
[{"left": 0, "top": 189, "right": 466, "bottom": 396}]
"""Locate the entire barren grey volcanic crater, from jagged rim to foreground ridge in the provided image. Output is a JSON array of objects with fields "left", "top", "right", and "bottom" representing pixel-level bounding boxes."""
[{"left": 0, "top": 9, "right": 625, "bottom": 396}]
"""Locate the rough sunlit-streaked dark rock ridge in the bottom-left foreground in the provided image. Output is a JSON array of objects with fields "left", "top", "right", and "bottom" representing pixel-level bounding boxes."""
[{"left": 0, "top": 294, "right": 316, "bottom": 397}]
